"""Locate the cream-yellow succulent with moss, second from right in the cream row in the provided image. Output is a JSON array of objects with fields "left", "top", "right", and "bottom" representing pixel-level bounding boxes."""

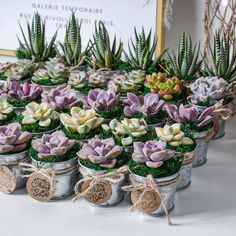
[{"left": 100, "top": 118, "right": 154, "bottom": 151}]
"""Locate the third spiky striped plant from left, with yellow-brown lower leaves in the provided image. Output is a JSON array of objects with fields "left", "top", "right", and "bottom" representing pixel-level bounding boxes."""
[{"left": 90, "top": 21, "right": 123, "bottom": 69}]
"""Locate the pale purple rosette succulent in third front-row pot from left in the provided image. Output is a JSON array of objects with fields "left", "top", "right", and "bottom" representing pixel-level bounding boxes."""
[{"left": 77, "top": 136, "right": 123, "bottom": 168}]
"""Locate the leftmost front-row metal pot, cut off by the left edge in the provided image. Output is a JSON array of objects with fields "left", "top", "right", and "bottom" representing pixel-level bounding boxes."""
[{"left": 0, "top": 150, "right": 29, "bottom": 190}]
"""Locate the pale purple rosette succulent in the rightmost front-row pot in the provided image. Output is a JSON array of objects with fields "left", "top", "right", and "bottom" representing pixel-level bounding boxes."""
[{"left": 132, "top": 140, "right": 175, "bottom": 168}]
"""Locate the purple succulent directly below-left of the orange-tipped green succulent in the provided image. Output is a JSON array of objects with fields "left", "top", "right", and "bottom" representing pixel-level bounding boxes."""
[{"left": 124, "top": 93, "right": 164, "bottom": 117}]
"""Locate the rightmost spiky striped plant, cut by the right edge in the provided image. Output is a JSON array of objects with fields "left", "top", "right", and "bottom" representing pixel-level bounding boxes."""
[{"left": 203, "top": 31, "right": 236, "bottom": 84}]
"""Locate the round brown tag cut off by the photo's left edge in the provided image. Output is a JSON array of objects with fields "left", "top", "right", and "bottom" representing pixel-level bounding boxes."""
[{"left": 0, "top": 166, "right": 16, "bottom": 193}]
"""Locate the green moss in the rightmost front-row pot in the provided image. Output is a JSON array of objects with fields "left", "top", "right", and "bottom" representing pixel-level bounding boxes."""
[{"left": 128, "top": 157, "right": 183, "bottom": 178}]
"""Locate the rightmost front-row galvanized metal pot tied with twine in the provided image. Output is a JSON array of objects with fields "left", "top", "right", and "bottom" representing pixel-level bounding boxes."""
[{"left": 130, "top": 172, "right": 179, "bottom": 216}]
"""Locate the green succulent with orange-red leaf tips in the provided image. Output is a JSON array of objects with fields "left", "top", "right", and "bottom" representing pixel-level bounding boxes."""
[{"left": 145, "top": 73, "right": 184, "bottom": 100}]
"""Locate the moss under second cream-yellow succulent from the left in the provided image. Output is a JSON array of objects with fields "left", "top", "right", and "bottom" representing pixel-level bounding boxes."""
[{"left": 16, "top": 115, "right": 60, "bottom": 133}]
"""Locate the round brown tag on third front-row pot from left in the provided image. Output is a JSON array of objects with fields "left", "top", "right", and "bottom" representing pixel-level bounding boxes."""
[{"left": 81, "top": 180, "right": 112, "bottom": 205}]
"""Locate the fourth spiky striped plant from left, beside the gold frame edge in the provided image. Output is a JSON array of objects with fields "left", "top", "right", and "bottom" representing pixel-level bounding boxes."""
[{"left": 124, "top": 28, "right": 166, "bottom": 71}]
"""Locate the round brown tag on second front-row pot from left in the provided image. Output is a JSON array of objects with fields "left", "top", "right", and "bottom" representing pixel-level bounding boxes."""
[{"left": 26, "top": 173, "right": 55, "bottom": 202}]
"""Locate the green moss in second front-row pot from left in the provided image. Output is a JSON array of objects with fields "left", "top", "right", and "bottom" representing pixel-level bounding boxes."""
[{"left": 29, "top": 143, "right": 80, "bottom": 163}]
